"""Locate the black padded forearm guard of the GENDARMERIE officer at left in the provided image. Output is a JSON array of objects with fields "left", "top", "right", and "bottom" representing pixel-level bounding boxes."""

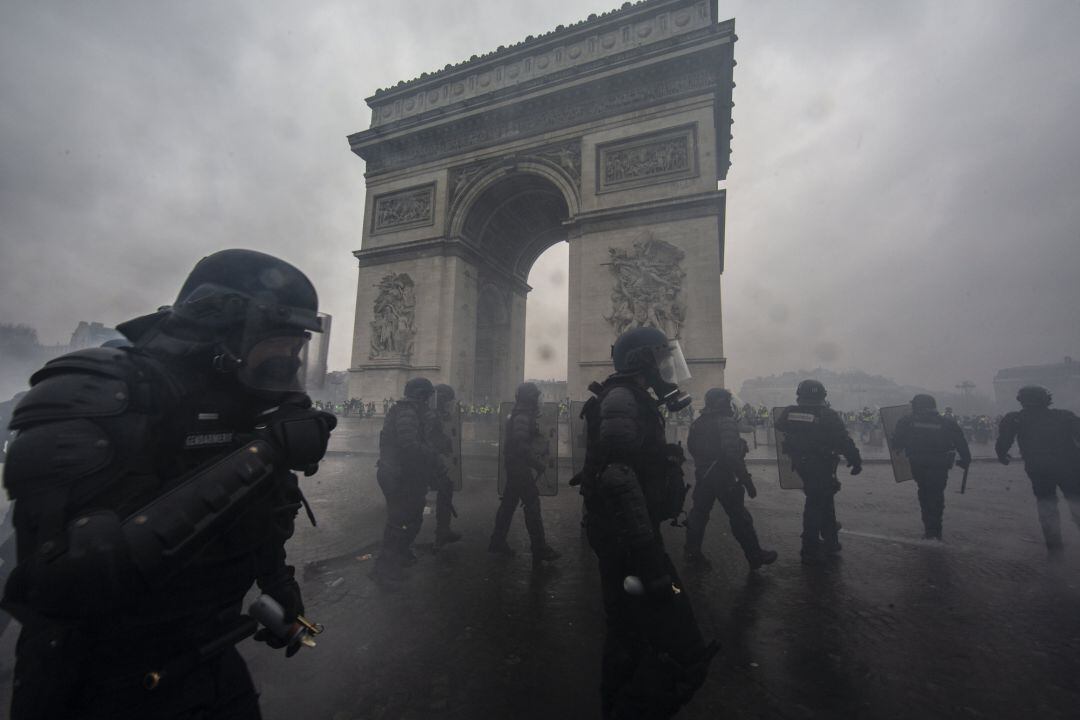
[{"left": 123, "top": 440, "right": 274, "bottom": 586}]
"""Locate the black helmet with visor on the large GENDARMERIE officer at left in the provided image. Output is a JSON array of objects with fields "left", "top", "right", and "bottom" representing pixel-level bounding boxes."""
[{"left": 163, "top": 249, "right": 323, "bottom": 393}]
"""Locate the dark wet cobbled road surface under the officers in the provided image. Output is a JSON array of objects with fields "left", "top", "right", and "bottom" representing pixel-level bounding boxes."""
[{"left": 0, "top": 453, "right": 1080, "bottom": 720}]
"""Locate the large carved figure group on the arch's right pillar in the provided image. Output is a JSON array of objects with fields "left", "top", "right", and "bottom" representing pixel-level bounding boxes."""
[{"left": 604, "top": 233, "right": 686, "bottom": 339}]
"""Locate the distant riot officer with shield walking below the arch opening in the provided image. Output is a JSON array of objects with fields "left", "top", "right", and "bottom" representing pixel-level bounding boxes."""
[{"left": 487, "top": 382, "right": 559, "bottom": 565}]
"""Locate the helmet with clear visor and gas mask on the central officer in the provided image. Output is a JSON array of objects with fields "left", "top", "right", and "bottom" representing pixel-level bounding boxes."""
[{"left": 611, "top": 327, "right": 691, "bottom": 412}]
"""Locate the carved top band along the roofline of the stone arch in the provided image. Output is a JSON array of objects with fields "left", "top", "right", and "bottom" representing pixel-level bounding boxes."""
[{"left": 366, "top": 0, "right": 733, "bottom": 127}]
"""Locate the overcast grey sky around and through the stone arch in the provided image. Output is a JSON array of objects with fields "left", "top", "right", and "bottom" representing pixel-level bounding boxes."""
[{"left": 0, "top": 0, "right": 1080, "bottom": 397}]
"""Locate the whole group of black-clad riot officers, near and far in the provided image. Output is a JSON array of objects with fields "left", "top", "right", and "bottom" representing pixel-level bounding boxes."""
[{"left": 2, "top": 250, "right": 1080, "bottom": 720}]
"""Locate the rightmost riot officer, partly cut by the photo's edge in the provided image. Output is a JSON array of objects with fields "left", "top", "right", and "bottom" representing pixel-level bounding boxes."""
[{"left": 995, "top": 385, "right": 1080, "bottom": 557}]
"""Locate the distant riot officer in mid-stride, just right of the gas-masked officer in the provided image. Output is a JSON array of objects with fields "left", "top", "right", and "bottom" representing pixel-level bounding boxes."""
[{"left": 686, "top": 388, "right": 777, "bottom": 570}]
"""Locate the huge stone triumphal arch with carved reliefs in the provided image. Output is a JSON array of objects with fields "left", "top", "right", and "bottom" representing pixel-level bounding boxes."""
[{"left": 349, "top": 0, "right": 737, "bottom": 402}]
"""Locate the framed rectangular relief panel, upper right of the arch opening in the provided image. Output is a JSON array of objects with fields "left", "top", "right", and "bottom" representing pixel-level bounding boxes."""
[{"left": 596, "top": 125, "right": 698, "bottom": 192}]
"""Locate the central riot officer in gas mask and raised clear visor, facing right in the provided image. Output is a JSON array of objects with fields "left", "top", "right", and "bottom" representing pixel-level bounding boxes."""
[{"left": 581, "top": 327, "right": 716, "bottom": 718}]
